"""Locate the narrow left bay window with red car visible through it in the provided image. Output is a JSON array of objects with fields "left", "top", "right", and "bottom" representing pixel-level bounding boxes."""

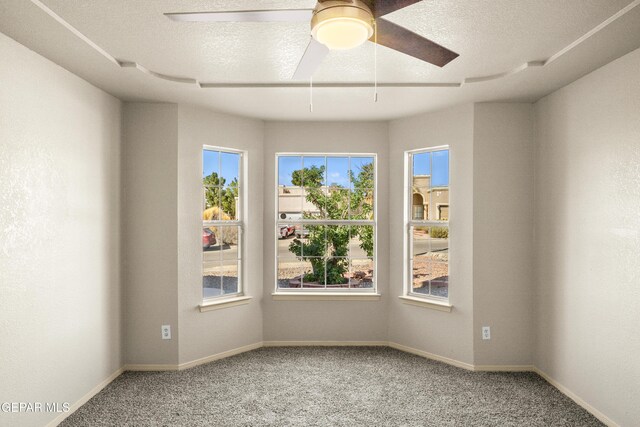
[{"left": 202, "top": 147, "right": 244, "bottom": 299}]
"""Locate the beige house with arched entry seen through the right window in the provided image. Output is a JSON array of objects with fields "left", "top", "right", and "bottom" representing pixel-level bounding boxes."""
[{"left": 411, "top": 175, "right": 449, "bottom": 221}]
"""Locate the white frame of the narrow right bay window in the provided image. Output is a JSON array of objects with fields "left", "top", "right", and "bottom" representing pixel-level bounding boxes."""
[{"left": 402, "top": 145, "right": 451, "bottom": 304}]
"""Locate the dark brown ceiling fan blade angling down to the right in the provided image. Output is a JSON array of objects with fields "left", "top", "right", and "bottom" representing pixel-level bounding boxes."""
[{"left": 369, "top": 19, "right": 459, "bottom": 67}]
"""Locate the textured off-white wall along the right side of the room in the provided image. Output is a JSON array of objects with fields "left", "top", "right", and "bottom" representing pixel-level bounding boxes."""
[{"left": 535, "top": 50, "right": 640, "bottom": 426}]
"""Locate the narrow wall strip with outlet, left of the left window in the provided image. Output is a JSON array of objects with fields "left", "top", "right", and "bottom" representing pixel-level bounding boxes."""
[{"left": 122, "top": 103, "right": 180, "bottom": 364}]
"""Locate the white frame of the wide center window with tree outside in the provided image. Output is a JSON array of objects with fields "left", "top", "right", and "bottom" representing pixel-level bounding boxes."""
[{"left": 271, "top": 152, "right": 378, "bottom": 299}]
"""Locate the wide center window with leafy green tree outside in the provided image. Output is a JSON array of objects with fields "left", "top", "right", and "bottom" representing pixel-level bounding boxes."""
[{"left": 275, "top": 154, "right": 376, "bottom": 292}]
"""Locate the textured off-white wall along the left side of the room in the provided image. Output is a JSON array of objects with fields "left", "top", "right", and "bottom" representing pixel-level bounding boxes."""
[{"left": 0, "top": 30, "right": 122, "bottom": 426}]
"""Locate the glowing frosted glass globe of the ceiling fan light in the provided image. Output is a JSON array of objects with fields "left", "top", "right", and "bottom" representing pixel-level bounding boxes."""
[{"left": 311, "top": 17, "right": 373, "bottom": 50}]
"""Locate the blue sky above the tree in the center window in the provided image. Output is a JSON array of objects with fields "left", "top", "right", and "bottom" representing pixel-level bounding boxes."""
[{"left": 278, "top": 156, "right": 373, "bottom": 188}]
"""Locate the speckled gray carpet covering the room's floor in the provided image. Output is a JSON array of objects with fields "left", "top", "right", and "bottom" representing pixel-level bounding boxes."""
[{"left": 62, "top": 347, "right": 602, "bottom": 427}]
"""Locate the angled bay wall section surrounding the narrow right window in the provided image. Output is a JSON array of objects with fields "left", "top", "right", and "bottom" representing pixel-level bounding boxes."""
[{"left": 389, "top": 105, "right": 474, "bottom": 364}]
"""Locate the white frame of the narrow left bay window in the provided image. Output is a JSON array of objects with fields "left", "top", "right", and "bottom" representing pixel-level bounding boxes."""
[{"left": 200, "top": 144, "right": 247, "bottom": 305}]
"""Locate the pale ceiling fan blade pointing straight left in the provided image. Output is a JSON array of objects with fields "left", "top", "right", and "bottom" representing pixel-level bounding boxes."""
[{"left": 164, "top": 9, "right": 313, "bottom": 22}]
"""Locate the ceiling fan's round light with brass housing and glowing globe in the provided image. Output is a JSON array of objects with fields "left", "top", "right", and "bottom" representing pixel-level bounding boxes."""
[{"left": 311, "top": 0, "right": 373, "bottom": 50}]
